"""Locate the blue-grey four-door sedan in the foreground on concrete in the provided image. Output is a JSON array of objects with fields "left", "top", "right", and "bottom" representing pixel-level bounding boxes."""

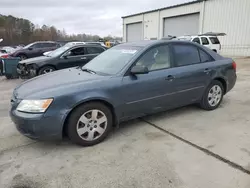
[{"left": 10, "top": 40, "right": 236, "bottom": 146}]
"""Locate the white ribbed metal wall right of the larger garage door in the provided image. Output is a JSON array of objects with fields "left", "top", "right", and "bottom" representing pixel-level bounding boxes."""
[{"left": 202, "top": 0, "right": 250, "bottom": 56}]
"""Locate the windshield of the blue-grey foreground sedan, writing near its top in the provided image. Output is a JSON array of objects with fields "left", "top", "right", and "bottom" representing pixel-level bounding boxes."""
[{"left": 83, "top": 46, "right": 140, "bottom": 75}]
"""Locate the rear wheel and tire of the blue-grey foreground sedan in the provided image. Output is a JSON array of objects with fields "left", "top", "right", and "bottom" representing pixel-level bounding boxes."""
[{"left": 200, "top": 80, "right": 224, "bottom": 111}]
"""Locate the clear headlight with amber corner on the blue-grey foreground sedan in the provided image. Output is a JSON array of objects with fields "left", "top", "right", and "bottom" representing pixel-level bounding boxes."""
[{"left": 17, "top": 99, "right": 53, "bottom": 113}]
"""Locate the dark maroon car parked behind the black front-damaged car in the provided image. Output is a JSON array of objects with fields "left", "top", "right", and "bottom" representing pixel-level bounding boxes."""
[{"left": 10, "top": 41, "right": 60, "bottom": 60}]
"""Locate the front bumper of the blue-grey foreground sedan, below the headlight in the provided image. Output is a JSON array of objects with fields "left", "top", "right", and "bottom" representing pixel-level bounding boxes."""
[{"left": 10, "top": 109, "right": 64, "bottom": 140}]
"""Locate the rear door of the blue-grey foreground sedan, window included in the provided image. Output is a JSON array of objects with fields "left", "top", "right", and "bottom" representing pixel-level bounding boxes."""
[{"left": 168, "top": 43, "right": 214, "bottom": 106}]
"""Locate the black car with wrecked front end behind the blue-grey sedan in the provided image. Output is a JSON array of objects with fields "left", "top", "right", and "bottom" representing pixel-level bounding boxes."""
[{"left": 17, "top": 44, "right": 106, "bottom": 77}]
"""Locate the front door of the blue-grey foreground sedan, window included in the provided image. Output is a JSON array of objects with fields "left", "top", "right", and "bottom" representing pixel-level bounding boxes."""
[{"left": 120, "top": 45, "right": 176, "bottom": 119}]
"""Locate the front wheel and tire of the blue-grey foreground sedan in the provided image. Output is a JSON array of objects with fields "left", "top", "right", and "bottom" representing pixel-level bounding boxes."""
[{"left": 66, "top": 102, "right": 113, "bottom": 146}]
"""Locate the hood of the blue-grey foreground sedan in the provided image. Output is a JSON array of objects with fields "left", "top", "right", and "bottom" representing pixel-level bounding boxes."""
[{"left": 14, "top": 68, "right": 110, "bottom": 99}]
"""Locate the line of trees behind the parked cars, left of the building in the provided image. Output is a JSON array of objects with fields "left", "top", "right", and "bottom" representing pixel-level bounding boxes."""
[{"left": 0, "top": 14, "right": 121, "bottom": 46}]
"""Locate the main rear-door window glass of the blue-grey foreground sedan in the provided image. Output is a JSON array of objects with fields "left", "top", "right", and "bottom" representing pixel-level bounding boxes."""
[{"left": 173, "top": 44, "right": 200, "bottom": 66}]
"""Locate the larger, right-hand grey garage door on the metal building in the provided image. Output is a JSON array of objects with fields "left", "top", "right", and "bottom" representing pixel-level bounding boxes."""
[{"left": 164, "top": 13, "right": 200, "bottom": 37}]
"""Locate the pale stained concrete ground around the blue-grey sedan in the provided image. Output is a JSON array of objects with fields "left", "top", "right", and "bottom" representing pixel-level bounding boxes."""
[{"left": 0, "top": 59, "right": 250, "bottom": 188}]
